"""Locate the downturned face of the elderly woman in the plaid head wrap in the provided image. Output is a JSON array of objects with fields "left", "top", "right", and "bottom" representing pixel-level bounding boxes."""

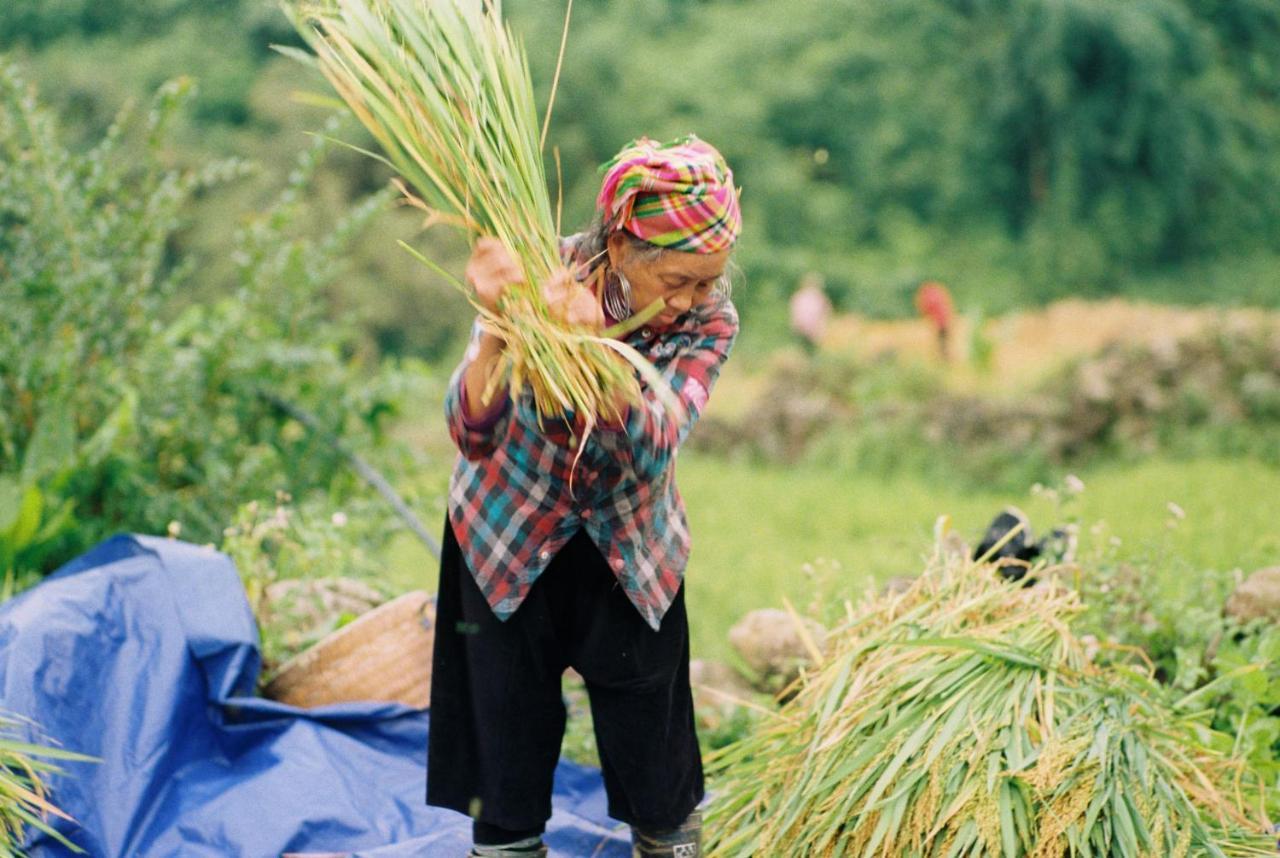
[{"left": 608, "top": 232, "right": 732, "bottom": 328}]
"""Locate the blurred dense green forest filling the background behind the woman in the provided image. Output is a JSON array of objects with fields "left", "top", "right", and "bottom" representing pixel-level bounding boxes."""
[{"left": 0, "top": 0, "right": 1280, "bottom": 360}]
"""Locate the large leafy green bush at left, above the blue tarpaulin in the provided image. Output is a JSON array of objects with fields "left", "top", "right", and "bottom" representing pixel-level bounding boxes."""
[{"left": 0, "top": 58, "right": 409, "bottom": 587}]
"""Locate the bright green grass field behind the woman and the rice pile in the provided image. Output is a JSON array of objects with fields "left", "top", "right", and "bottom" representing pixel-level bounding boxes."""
[{"left": 388, "top": 453, "right": 1280, "bottom": 658}]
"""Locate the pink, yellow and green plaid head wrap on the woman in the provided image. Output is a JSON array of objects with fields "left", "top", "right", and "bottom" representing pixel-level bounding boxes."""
[{"left": 595, "top": 134, "right": 742, "bottom": 254}]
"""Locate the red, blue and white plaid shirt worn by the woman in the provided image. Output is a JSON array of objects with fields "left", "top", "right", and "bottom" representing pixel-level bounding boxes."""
[{"left": 444, "top": 275, "right": 737, "bottom": 630}]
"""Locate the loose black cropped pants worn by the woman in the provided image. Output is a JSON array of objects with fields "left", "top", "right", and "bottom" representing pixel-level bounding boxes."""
[{"left": 426, "top": 522, "right": 704, "bottom": 831}]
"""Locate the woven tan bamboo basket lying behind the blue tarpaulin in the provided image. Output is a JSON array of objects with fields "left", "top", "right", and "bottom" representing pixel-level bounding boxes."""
[{"left": 264, "top": 590, "right": 435, "bottom": 709}]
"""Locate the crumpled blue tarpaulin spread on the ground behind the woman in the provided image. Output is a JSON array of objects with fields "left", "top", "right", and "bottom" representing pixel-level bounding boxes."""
[{"left": 0, "top": 535, "right": 630, "bottom": 858}]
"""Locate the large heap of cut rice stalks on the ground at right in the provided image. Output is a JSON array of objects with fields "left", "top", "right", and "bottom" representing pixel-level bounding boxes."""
[{"left": 707, "top": 540, "right": 1275, "bottom": 858}]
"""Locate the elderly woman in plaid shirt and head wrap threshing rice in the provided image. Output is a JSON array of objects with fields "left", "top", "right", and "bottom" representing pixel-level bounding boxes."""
[{"left": 426, "top": 137, "right": 741, "bottom": 857}]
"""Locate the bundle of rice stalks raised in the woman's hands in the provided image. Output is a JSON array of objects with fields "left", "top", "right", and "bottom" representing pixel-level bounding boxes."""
[{"left": 285, "top": 0, "right": 676, "bottom": 430}]
